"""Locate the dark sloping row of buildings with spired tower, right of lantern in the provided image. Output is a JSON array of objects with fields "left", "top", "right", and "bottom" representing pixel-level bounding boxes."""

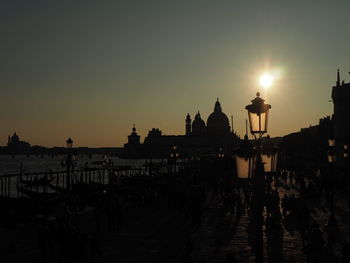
[{"left": 282, "top": 69, "right": 350, "bottom": 166}]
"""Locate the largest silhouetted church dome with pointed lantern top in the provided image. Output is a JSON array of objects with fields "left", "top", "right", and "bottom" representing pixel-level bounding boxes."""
[{"left": 207, "top": 99, "right": 230, "bottom": 135}]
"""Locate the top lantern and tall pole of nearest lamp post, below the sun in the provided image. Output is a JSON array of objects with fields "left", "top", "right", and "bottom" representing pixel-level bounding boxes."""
[{"left": 245, "top": 92, "right": 272, "bottom": 263}]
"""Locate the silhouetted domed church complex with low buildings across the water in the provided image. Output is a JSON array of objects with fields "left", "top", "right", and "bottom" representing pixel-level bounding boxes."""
[{"left": 123, "top": 100, "right": 239, "bottom": 157}]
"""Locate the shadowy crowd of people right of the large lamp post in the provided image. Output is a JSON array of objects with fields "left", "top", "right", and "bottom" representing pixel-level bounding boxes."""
[{"left": 266, "top": 171, "right": 350, "bottom": 263}]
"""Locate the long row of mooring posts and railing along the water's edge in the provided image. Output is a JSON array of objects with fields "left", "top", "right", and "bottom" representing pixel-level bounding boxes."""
[{"left": 0, "top": 159, "right": 184, "bottom": 198}]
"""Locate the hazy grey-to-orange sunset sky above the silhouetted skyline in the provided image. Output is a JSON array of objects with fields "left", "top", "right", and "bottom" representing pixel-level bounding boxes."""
[{"left": 0, "top": 0, "right": 350, "bottom": 147}]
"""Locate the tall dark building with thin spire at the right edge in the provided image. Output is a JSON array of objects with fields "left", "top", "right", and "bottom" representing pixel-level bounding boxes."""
[{"left": 332, "top": 69, "right": 350, "bottom": 165}]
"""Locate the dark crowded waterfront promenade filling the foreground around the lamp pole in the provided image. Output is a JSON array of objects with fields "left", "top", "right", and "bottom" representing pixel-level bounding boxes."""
[{"left": 0, "top": 166, "right": 350, "bottom": 263}]
